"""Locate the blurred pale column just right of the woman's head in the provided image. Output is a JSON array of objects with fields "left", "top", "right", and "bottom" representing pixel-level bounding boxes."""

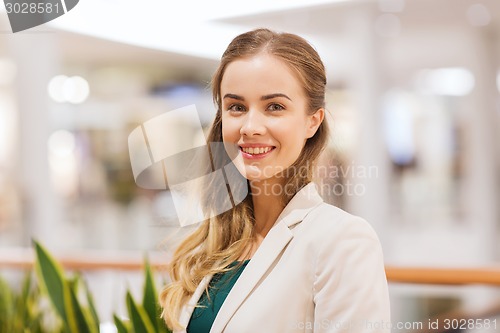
[{"left": 348, "top": 5, "right": 390, "bottom": 247}]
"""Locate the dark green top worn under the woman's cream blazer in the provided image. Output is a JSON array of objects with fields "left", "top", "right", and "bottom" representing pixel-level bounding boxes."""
[{"left": 187, "top": 260, "right": 250, "bottom": 333}]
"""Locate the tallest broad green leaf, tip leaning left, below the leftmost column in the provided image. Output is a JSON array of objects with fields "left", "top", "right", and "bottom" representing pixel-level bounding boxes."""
[{"left": 33, "top": 241, "right": 78, "bottom": 332}]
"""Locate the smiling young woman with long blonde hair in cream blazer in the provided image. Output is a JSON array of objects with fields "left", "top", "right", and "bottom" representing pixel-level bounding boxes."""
[{"left": 160, "top": 29, "right": 390, "bottom": 333}]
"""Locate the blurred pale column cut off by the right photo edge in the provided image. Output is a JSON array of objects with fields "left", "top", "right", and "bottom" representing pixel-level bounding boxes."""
[{"left": 464, "top": 27, "right": 500, "bottom": 261}]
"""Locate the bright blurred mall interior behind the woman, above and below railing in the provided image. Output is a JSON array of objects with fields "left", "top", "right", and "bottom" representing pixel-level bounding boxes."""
[{"left": 0, "top": 0, "right": 500, "bottom": 332}]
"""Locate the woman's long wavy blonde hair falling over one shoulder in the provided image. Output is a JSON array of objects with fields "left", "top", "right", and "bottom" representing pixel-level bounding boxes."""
[{"left": 160, "top": 29, "right": 328, "bottom": 328}]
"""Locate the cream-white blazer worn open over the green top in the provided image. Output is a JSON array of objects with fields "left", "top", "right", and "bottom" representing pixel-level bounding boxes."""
[{"left": 175, "top": 183, "right": 390, "bottom": 333}]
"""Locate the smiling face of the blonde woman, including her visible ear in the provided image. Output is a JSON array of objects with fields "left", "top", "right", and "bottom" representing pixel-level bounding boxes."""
[{"left": 220, "top": 53, "right": 324, "bottom": 181}]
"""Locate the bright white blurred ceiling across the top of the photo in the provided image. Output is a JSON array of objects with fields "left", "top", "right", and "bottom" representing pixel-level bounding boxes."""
[{"left": 0, "top": 0, "right": 500, "bottom": 85}]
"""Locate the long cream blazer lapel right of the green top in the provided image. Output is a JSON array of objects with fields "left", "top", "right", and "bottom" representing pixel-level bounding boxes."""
[{"left": 208, "top": 183, "right": 323, "bottom": 333}]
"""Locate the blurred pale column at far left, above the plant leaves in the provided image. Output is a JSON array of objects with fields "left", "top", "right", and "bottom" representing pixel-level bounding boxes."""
[{"left": 7, "top": 31, "right": 62, "bottom": 248}]
